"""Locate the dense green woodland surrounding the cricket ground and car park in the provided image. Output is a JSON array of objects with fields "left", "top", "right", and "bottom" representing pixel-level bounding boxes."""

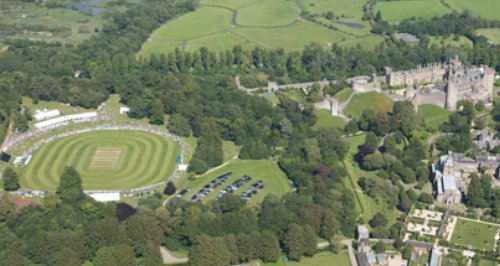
[{"left": 0, "top": 0, "right": 500, "bottom": 266}]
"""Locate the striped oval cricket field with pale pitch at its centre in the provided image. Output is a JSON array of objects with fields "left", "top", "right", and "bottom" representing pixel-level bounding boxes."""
[{"left": 21, "top": 130, "right": 180, "bottom": 190}]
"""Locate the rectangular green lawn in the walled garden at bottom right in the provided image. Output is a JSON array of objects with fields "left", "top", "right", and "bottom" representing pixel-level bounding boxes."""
[{"left": 451, "top": 218, "right": 498, "bottom": 251}]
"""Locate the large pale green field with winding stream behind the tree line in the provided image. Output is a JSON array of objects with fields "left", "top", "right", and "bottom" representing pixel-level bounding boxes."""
[{"left": 138, "top": 0, "right": 383, "bottom": 57}]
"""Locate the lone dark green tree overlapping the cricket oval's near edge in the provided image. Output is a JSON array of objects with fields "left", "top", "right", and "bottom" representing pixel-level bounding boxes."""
[{"left": 56, "top": 167, "right": 86, "bottom": 203}]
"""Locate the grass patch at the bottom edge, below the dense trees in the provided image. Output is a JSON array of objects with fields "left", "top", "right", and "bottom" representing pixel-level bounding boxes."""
[{"left": 263, "top": 251, "right": 351, "bottom": 266}]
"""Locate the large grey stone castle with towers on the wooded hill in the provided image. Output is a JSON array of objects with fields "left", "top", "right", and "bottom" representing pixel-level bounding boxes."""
[{"left": 385, "top": 57, "right": 495, "bottom": 110}]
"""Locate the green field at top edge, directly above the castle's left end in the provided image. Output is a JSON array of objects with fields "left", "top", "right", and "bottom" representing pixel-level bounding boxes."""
[{"left": 375, "top": 0, "right": 454, "bottom": 23}]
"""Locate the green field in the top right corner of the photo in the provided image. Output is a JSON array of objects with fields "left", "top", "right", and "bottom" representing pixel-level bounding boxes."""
[{"left": 445, "top": 0, "right": 500, "bottom": 19}]
